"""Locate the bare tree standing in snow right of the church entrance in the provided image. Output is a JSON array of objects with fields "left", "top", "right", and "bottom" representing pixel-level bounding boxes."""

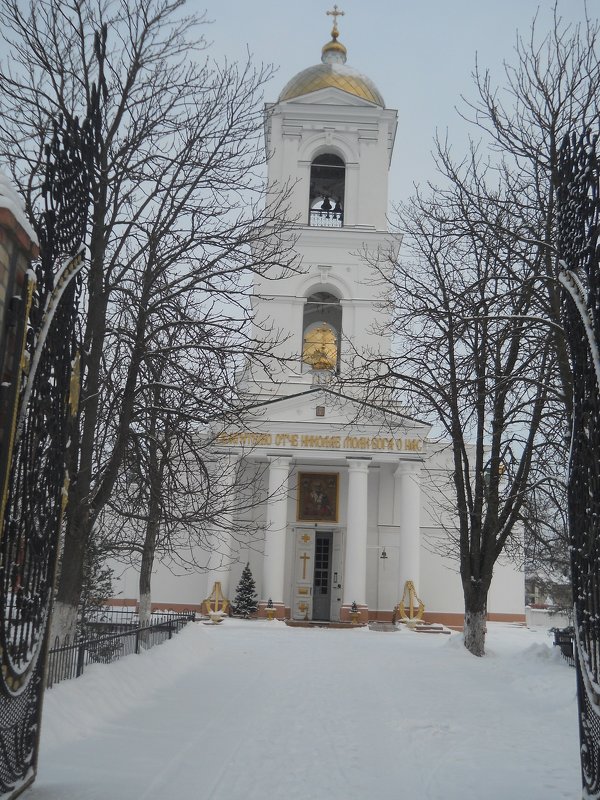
[{"left": 356, "top": 183, "right": 553, "bottom": 655}]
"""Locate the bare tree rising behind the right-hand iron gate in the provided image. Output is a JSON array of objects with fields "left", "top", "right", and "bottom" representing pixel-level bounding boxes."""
[{"left": 454, "top": 2, "right": 600, "bottom": 416}]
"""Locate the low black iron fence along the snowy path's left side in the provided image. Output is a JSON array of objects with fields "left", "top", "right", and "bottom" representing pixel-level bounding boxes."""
[{"left": 46, "top": 611, "right": 195, "bottom": 688}]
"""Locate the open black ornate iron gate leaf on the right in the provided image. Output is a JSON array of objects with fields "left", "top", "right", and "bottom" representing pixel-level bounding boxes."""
[{"left": 558, "top": 128, "right": 600, "bottom": 798}]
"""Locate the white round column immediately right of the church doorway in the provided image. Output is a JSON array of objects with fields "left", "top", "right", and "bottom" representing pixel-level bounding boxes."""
[{"left": 343, "top": 458, "right": 370, "bottom": 607}]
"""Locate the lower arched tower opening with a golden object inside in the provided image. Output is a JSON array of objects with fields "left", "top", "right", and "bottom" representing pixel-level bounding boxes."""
[{"left": 302, "top": 292, "right": 342, "bottom": 372}]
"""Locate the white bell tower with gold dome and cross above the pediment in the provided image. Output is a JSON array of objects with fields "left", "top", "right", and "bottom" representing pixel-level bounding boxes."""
[{"left": 248, "top": 6, "right": 397, "bottom": 397}]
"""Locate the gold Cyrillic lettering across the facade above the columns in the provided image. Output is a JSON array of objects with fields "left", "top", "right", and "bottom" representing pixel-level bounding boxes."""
[{"left": 216, "top": 431, "right": 423, "bottom": 453}]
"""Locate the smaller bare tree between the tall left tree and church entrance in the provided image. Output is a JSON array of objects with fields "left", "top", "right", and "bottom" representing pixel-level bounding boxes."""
[{"left": 98, "top": 309, "right": 267, "bottom": 623}]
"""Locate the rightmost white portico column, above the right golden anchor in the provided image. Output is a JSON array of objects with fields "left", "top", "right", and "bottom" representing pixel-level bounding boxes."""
[{"left": 394, "top": 461, "right": 421, "bottom": 594}]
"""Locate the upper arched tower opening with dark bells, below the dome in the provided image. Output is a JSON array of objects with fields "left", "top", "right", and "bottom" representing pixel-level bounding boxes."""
[{"left": 308, "top": 153, "right": 346, "bottom": 228}]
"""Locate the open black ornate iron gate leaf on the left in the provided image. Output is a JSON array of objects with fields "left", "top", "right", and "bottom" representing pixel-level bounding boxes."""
[{"left": 0, "top": 114, "right": 93, "bottom": 798}]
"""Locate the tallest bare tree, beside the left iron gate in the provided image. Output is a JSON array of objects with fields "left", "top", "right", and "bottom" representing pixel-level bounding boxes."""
[{"left": 0, "top": 0, "right": 296, "bottom": 636}]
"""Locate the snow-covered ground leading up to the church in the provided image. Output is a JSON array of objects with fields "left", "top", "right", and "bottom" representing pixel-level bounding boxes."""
[{"left": 29, "top": 619, "right": 581, "bottom": 800}]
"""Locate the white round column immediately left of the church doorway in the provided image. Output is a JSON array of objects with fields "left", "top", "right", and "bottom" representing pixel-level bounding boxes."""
[{"left": 262, "top": 456, "right": 292, "bottom": 605}]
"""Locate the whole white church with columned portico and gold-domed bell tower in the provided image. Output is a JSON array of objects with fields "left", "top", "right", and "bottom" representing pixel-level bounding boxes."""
[{"left": 110, "top": 9, "right": 524, "bottom": 625}]
